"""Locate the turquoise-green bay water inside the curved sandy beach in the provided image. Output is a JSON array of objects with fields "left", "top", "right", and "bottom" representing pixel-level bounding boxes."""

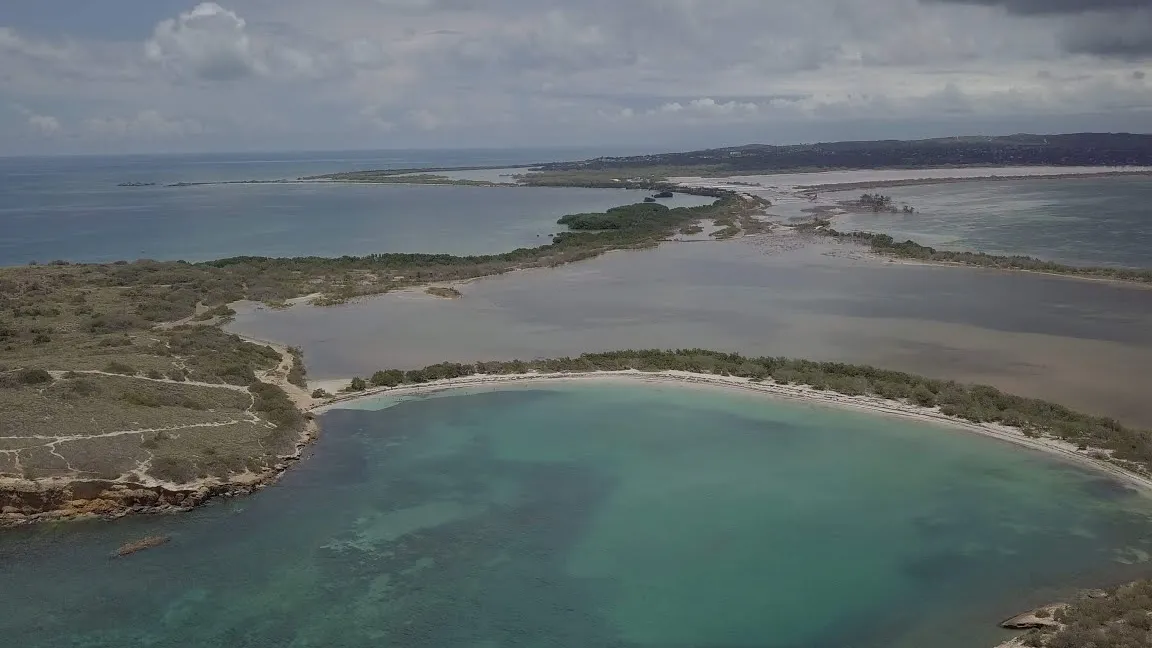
[{"left": 0, "top": 384, "right": 1152, "bottom": 648}]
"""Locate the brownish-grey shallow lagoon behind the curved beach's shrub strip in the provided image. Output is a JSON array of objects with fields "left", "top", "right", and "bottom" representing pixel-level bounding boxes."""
[{"left": 232, "top": 235, "right": 1152, "bottom": 425}]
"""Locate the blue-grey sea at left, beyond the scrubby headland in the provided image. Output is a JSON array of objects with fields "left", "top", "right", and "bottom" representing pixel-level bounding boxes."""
[{"left": 0, "top": 150, "right": 702, "bottom": 265}]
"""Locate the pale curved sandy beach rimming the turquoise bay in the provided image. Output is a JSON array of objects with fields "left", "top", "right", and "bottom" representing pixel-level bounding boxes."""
[{"left": 310, "top": 370, "right": 1152, "bottom": 493}]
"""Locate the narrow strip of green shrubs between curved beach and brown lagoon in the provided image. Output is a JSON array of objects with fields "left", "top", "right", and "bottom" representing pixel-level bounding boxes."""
[{"left": 349, "top": 349, "right": 1152, "bottom": 474}]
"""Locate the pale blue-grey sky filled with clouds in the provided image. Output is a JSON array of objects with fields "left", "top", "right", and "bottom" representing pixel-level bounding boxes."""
[{"left": 0, "top": 0, "right": 1152, "bottom": 155}]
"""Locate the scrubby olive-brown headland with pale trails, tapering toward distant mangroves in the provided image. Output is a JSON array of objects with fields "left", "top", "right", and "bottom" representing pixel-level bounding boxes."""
[{"left": 0, "top": 190, "right": 761, "bottom": 491}]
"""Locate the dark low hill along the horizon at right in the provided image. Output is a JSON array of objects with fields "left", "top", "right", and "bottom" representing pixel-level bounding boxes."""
[{"left": 543, "top": 133, "right": 1152, "bottom": 172}]
